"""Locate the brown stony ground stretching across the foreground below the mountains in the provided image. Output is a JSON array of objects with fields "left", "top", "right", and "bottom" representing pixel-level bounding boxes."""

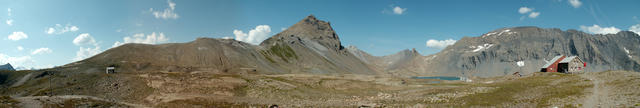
[{"left": 1, "top": 71, "right": 640, "bottom": 107}]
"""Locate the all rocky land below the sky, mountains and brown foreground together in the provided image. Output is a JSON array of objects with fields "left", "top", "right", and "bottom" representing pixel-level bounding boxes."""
[{"left": 0, "top": 16, "right": 640, "bottom": 107}]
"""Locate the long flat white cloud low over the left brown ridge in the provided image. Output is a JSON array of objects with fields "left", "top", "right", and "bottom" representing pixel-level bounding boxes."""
[{"left": 112, "top": 32, "right": 169, "bottom": 47}]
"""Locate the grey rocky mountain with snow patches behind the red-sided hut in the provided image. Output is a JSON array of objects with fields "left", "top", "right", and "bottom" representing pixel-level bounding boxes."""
[{"left": 396, "top": 27, "right": 640, "bottom": 77}]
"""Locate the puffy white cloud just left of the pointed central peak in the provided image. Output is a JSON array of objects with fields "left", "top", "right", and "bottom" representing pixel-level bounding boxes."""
[{"left": 233, "top": 25, "right": 271, "bottom": 45}]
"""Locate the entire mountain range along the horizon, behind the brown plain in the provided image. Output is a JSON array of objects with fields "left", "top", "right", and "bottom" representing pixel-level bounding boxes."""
[{"left": 63, "top": 15, "right": 640, "bottom": 77}]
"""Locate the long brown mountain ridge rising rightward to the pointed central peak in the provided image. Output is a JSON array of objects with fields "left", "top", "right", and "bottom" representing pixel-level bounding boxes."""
[{"left": 71, "top": 15, "right": 376, "bottom": 74}]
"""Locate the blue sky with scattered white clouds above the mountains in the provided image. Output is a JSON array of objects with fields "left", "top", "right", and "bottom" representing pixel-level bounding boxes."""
[{"left": 0, "top": 0, "right": 640, "bottom": 69}]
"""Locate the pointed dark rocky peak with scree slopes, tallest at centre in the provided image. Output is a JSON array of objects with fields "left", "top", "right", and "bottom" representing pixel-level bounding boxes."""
[{"left": 260, "top": 15, "right": 376, "bottom": 74}]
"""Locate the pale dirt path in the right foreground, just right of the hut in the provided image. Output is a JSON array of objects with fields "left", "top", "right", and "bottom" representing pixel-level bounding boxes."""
[{"left": 580, "top": 73, "right": 614, "bottom": 108}]
